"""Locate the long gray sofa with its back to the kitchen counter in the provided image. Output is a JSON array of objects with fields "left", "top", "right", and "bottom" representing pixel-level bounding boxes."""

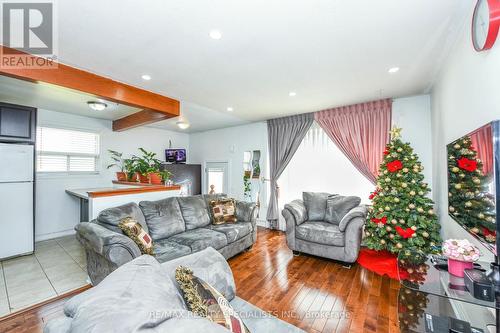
[{"left": 79, "top": 195, "right": 257, "bottom": 285}]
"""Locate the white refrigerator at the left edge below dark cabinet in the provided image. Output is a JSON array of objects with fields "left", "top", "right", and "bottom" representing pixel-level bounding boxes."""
[{"left": 0, "top": 143, "right": 34, "bottom": 259}]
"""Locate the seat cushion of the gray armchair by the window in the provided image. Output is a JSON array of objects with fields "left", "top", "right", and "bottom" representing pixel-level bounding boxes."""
[{"left": 295, "top": 221, "right": 344, "bottom": 246}]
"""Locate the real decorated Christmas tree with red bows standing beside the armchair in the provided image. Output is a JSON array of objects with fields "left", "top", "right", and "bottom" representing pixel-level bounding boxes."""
[{"left": 365, "top": 128, "right": 441, "bottom": 253}]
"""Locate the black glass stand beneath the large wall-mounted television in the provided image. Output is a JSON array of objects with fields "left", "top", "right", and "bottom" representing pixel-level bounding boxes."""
[{"left": 398, "top": 251, "right": 500, "bottom": 333}]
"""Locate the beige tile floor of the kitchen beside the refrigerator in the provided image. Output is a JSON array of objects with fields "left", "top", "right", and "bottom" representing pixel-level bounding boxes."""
[{"left": 0, "top": 236, "right": 88, "bottom": 317}]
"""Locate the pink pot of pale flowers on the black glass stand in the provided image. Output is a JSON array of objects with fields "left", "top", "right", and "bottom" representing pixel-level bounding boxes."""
[{"left": 443, "top": 239, "right": 481, "bottom": 277}]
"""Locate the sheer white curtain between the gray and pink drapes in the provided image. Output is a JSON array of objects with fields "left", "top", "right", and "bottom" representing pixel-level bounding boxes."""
[{"left": 278, "top": 122, "right": 374, "bottom": 230}]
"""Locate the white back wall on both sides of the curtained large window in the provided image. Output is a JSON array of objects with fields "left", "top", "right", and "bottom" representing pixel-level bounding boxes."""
[{"left": 188, "top": 95, "right": 432, "bottom": 227}]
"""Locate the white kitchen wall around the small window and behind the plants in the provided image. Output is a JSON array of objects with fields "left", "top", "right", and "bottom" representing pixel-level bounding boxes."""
[{"left": 35, "top": 109, "right": 189, "bottom": 240}]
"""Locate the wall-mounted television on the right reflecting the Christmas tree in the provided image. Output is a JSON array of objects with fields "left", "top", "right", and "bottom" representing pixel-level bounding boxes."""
[{"left": 446, "top": 121, "right": 500, "bottom": 262}]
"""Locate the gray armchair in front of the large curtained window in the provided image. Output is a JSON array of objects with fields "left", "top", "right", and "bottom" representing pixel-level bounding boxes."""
[{"left": 282, "top": 192, "right": 368, "bottom": 263}]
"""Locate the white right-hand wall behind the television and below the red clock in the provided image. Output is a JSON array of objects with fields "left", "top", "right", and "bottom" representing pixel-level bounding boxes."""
[{"left": 431, "top": 8, "right": 500, "bottom": 260}]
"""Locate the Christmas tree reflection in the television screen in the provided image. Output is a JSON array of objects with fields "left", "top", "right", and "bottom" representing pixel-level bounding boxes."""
[{"left": 448, "top": 136, "right": 496, "bottom": 243}]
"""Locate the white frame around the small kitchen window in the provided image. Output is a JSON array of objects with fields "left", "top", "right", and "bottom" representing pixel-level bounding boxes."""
[{"left": 35, "top": 124, "right": 102, "bottom": 178}]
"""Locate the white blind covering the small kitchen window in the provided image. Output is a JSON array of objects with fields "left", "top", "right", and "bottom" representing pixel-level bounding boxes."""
[{"left": 36, "top": 127, "right": 99, "bottom": 172}]
